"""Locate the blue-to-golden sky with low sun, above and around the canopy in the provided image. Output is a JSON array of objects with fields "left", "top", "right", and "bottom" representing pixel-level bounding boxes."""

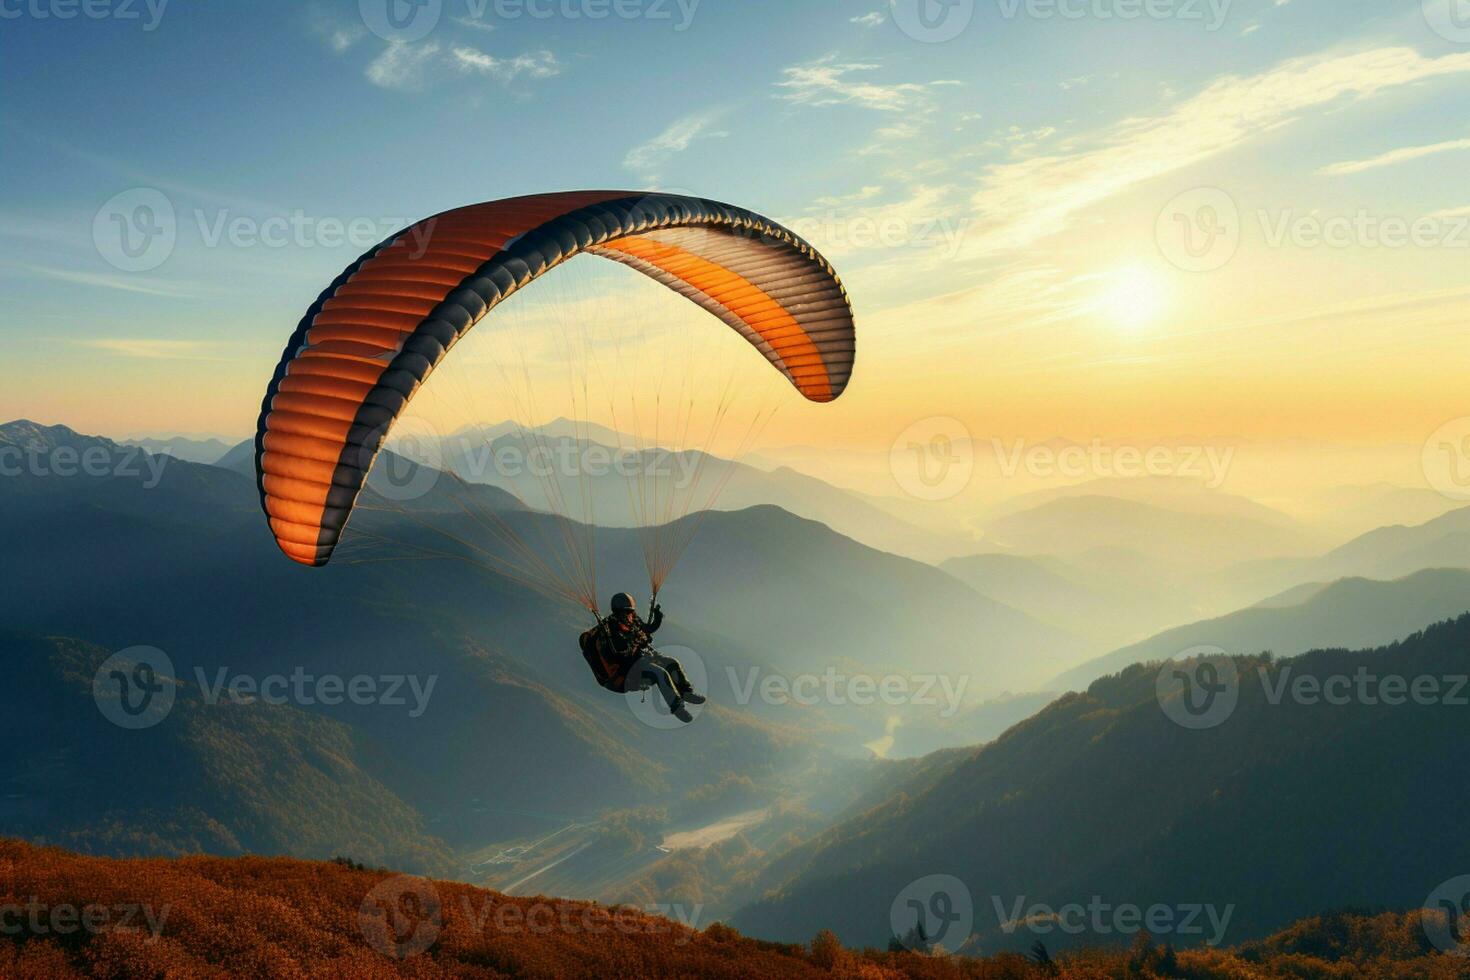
[{"left": 0, "top": 0, "right": 1470, "bottom": 448}]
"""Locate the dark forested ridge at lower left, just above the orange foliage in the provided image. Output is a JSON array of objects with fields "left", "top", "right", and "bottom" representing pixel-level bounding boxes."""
[{"left": 0, "top": 633, "right": 453, "bottom": 873}]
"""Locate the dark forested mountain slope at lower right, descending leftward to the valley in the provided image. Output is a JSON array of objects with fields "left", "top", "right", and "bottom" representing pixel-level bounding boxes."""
[{"left": 734, "top": 616, "right": 1470, "bottom": 949}]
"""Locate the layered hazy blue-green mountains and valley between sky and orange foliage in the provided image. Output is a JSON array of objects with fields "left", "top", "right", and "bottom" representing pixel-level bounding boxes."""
[{"left": 0, "top": 423, "right": 1470, "bottom": 951}]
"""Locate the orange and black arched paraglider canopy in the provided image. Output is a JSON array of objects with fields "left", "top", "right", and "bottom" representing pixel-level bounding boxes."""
[{"left": 256, "top": 191, "right": 856, "bottom": 578}]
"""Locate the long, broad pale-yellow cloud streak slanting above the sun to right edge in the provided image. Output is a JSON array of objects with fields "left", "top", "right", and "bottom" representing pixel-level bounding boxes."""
[{"left": 967, "top": 47, "right": 1470, "bottom": 254}]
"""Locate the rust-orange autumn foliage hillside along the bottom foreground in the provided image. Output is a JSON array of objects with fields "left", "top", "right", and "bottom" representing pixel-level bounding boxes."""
[{"left": 0, "top": 839, "right": 1466, "bottom": 980}]
